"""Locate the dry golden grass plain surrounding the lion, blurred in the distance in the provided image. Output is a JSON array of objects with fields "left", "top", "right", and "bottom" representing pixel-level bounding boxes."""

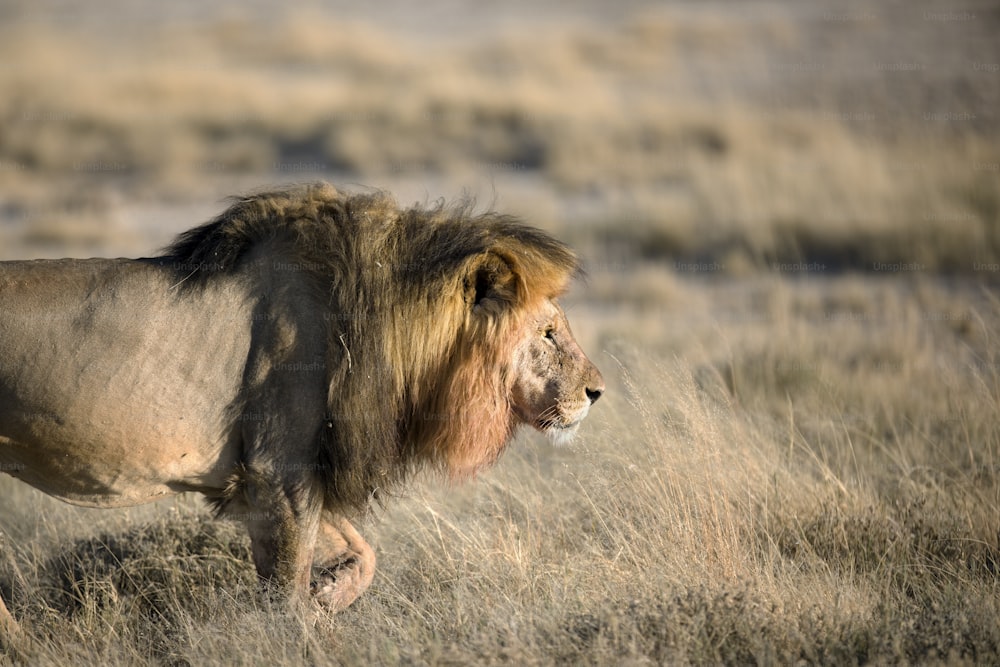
[{"left": 0, "top": 0, "right": 1000, "bottom": 665}]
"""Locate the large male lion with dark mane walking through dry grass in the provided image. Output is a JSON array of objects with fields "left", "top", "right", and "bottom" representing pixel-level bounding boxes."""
[{"left": 0, "top": 183, "right": 604, "bottom": 632}]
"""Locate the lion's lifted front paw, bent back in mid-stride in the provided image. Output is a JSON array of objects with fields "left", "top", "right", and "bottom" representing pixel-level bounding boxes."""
[{"left": 312, "top": 517, "right": 375, "bottom": 612}]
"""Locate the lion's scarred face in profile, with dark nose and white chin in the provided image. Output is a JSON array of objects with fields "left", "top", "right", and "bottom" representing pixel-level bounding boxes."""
[{"left": 512, "top": 301, "right": 604, "bottom": 442}]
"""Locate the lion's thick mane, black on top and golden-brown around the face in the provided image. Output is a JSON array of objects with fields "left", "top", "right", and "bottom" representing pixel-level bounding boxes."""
[{"left": 159, "top": 183, "right": 578, "bottom": 509}]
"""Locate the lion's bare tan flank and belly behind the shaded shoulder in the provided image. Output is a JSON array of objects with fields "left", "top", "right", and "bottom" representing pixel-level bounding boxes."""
[{"left": 0, "top": 261, "right": 249, "bottom": 507}]
